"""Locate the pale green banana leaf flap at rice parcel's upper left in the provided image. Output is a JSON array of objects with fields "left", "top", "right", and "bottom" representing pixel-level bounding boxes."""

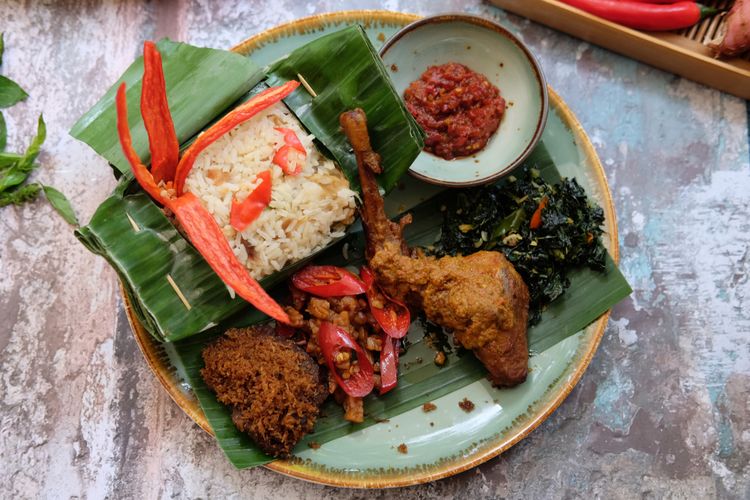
[{"left": 70, "top": 39, "right": 265, "bottom": 173}]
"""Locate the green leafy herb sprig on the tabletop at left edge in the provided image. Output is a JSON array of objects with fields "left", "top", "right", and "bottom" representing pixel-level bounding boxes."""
[{"left": 0, "top": 33, "right": 79, "bottom": 226}]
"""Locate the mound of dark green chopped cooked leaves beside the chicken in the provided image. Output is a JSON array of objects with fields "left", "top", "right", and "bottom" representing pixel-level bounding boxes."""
[{"left": 437, "top": 169, "right": 606, "bottom": 324}]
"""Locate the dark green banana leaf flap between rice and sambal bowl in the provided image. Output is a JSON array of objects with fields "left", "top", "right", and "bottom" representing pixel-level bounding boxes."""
[{"left": 266, "top": 26, "right": 424, "bottom": 192}]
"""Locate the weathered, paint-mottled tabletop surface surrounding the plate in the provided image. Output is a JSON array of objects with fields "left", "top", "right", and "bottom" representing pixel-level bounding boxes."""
[{"left": 0, "top": 0, "right": 750, "bottom": 498}]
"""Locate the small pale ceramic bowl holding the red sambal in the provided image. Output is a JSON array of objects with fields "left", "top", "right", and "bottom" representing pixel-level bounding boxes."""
[{"left": 380, "top": 14, "right": 548, "bottom": 187}]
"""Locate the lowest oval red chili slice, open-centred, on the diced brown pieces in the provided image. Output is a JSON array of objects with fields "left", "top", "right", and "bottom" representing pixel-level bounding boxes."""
[{"left": 318, "top": 321, "right": 375, "bottom": 398}]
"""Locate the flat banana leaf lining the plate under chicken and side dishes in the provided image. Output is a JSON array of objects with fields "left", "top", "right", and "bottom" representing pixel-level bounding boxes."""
[{"left": 167, "top": 143, "right": 631, "bottom": 468}]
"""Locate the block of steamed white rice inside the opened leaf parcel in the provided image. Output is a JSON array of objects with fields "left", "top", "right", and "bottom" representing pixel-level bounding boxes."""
[{"left": 185, "top": 103, "right": 356, "bottom": 279}]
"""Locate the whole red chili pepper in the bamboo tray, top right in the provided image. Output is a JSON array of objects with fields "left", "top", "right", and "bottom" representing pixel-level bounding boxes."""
[{"left": 562, "top": 0, "right": 718, "bottom": 31}]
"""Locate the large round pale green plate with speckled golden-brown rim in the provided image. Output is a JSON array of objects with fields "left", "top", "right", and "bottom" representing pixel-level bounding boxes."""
[{"left": 126, "top": 11, "right": 618, "bottom": 488}]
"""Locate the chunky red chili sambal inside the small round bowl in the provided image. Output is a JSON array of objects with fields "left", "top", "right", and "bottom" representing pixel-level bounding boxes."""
[{"left": 404, "top": 63, "right": 505, "bottom": 160}]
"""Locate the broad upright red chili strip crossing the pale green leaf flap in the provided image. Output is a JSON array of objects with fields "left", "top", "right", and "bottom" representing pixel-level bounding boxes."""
[{"left": 141, "top": 42, "right": 180, "bottom": 184}]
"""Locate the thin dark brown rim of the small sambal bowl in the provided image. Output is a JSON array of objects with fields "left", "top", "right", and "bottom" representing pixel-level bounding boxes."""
[{"left": 378, "top": 12, "right": 549, "bottom": 188}]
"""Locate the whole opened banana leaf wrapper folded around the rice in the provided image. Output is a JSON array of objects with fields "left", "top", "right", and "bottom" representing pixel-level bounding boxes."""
[{"left": 71, "top": 28, "right": 423, "bottom": 341}]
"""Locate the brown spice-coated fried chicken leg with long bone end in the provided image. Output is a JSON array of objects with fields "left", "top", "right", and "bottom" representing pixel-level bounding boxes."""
[{"left": 340, "top": 109, "right": 529, "bottom": 387}]
